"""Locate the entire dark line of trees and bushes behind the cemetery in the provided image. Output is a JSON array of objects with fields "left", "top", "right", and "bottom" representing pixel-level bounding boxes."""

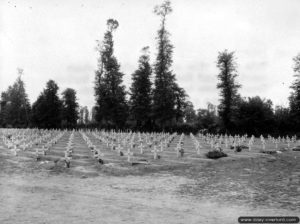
[{"left": 0, "top": 1, "right": 300, "bottom": 136}]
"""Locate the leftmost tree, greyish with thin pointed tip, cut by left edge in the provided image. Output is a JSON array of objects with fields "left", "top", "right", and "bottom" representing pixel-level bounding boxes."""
[{"left": 0, "top": 69, "right": 31, "bottom": 127}]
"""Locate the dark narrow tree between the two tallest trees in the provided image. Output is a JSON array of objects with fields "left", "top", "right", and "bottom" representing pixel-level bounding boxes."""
[{"left": 130, "top": 47, "right": 152, "bottom": 129}]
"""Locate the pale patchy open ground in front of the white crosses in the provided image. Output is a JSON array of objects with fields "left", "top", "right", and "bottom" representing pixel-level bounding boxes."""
[{"left": 0, "top": 132, "right": 300, "bottom": 224}]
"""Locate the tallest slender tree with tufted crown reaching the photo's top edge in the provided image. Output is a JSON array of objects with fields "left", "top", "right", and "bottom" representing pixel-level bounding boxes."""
[{"left": 153, "top": 1, "right": 180, "bottom": 129}]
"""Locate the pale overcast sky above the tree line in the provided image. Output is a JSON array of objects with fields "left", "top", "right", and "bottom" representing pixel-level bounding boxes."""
[{"left": 0, "top": 0, "right": 300, "bottom": 109}]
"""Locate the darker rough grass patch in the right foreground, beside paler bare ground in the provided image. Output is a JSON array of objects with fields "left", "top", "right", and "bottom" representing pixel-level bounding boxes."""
[{"left": 175, "top": 152, "right": 300, "bottom": 211}]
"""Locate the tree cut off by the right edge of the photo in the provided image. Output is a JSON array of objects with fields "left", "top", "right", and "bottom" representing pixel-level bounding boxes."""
[{"left": 289, "top": 54, "right": 300, "bottom": 131}]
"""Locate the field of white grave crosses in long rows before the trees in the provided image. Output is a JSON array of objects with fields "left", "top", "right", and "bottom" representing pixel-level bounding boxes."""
[{"left": 0, "top": 129, "right": 299, "bottom": 173}]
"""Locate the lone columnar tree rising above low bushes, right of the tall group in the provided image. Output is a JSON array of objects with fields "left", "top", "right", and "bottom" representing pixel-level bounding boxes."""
[{"left": 217, "top": 50, "right": 241, "bottom": 132}]
